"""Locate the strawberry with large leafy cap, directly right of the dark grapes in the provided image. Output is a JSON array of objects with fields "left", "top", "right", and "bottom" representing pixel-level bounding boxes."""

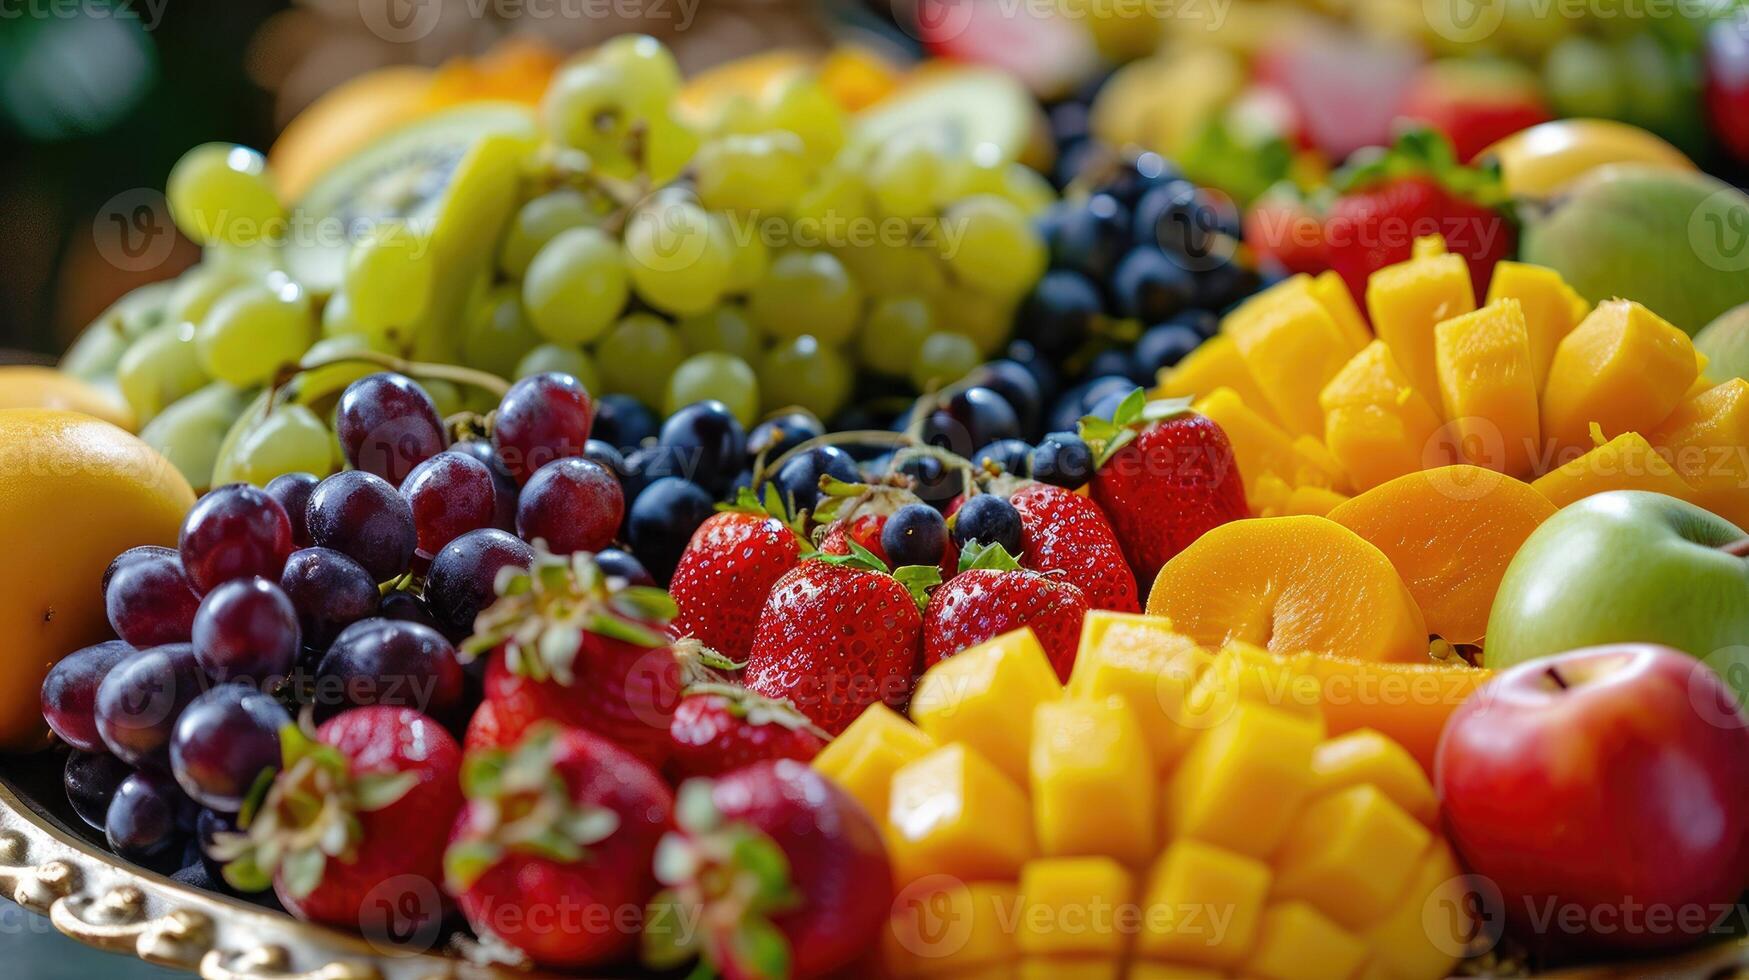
[{"left": 463, "top": 550, "right": 682, "bottom": 767}]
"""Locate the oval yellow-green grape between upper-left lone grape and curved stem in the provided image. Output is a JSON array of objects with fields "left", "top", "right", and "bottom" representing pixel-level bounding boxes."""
[{"left": 194, "top": 277, "right": 315, "bottom": 387}]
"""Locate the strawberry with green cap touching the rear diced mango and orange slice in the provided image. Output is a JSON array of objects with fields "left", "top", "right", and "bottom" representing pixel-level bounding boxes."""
[{"left": 1081, "top": 389, "right": 1251, "bottom": 590}]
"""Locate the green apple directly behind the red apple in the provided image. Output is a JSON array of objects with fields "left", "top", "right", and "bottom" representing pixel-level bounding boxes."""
[{"left": 1483, "top": 490, "right": 1749, "bottom": 697}]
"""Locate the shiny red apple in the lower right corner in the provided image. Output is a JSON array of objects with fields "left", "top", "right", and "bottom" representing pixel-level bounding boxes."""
[{"left": 1434, "top": 644, "right": 1749, "bottom": 956}]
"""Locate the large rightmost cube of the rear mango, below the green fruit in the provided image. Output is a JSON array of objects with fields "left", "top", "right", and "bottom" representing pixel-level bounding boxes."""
[{"left": 1543, "top": 299, "right": 1697, "bottom": 450}]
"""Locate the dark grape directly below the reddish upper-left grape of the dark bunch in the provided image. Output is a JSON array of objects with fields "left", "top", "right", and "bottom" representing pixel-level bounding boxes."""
[{"left": 194, "top": 579, "right": 303, "bottom": 681}]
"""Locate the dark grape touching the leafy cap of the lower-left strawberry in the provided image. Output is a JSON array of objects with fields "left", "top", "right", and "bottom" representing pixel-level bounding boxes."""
[{"left": 170, "top": 684, "right": 292, "bottom": 814}]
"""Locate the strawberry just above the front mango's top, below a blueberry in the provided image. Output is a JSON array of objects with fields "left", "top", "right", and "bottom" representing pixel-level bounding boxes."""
[{"left": 923, "top": 543, "right": 1088, "bottom": 683}]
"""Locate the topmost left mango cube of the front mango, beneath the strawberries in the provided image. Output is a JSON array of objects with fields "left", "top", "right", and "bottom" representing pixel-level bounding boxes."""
[{"left": 911, "top": 627, "right": 1063, "bottom": 786}]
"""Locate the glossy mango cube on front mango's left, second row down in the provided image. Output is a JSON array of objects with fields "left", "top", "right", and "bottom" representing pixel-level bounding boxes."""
[{"left": 887, "top": 742, "right": 1037, "bottom": 884}]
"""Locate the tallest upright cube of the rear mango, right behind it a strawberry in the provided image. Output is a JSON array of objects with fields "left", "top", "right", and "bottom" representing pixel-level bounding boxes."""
[{"left": 1366, "top": 239, "right": 1476, "bottom": 407}]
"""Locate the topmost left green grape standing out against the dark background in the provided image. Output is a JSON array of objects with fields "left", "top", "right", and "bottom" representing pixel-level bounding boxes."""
[{"left": 164, "top": 144, "right": 285, "bottom": 245}]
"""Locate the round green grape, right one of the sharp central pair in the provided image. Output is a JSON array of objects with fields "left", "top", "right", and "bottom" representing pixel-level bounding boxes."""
[{"left": 622, "top": 198, "right": 735, "bottom": 315}]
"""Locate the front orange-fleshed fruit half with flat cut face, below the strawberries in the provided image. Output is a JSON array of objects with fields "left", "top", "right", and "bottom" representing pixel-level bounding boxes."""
[{"left": 1147, "top": 516, "right": 1427, "bottom": 662}]
